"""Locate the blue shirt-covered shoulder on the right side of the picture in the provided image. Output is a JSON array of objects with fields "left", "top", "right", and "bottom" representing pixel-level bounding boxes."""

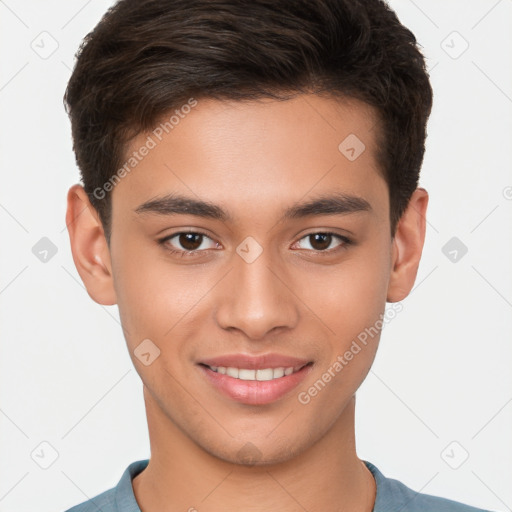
[{"left": 364, "top": 461, "right": 498, "bottom": 512}]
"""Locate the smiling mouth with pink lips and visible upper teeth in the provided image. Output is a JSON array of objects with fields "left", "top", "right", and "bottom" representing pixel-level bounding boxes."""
[{"left": 197, "top": 355, "right": 313, "bottom": 405}]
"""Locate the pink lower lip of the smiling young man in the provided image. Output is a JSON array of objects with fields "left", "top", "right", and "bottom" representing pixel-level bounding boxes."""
[{"left": 199, "top": 364, "right": 312, "bottom": 405}]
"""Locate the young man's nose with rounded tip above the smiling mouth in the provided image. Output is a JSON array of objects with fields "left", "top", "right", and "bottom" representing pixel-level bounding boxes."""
[{"left": 215, "top": 247, "right": 299, "bottom": 340}]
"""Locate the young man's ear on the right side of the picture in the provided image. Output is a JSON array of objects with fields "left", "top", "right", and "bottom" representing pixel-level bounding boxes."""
[{"left": 386, "top": 187, "right": 428, "bottom": 302}]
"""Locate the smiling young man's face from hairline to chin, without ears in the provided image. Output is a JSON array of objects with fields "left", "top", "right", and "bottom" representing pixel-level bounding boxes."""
[{"left": 76, "top": 95, "right": 416, "bottom": 464}]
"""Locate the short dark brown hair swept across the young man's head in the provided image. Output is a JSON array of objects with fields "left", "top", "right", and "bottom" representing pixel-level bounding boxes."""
[{"left": 64, "top": 0, "right": 432, "bottom": 240}]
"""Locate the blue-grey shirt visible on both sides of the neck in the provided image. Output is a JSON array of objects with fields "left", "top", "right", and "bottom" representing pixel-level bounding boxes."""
[{"left": 66, "top": 459, "right": 489, "bottom": 512}]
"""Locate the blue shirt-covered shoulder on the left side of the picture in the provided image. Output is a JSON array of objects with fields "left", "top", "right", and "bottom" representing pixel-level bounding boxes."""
[{"left": 65, "top": 459, "right": 149, "bottom": 512}]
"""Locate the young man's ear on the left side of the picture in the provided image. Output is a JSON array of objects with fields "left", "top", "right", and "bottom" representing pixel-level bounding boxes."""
[{"left": 66, "top": 184, "right": 117, "bottom": 305}]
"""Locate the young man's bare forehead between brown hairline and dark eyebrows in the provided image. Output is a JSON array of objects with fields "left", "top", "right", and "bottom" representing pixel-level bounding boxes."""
[{"left": 112, "top": 94, "right": 388, "bottom": 223}]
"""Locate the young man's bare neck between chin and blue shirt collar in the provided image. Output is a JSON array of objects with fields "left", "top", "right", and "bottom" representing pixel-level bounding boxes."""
[{"left": 133, "top": 389, "right": 376, "bottom": 512}]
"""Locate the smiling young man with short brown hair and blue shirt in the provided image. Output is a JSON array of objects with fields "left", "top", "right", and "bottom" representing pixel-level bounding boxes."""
[{"left": 64, "top": 0, "right": 494, "bottom": 512}]
